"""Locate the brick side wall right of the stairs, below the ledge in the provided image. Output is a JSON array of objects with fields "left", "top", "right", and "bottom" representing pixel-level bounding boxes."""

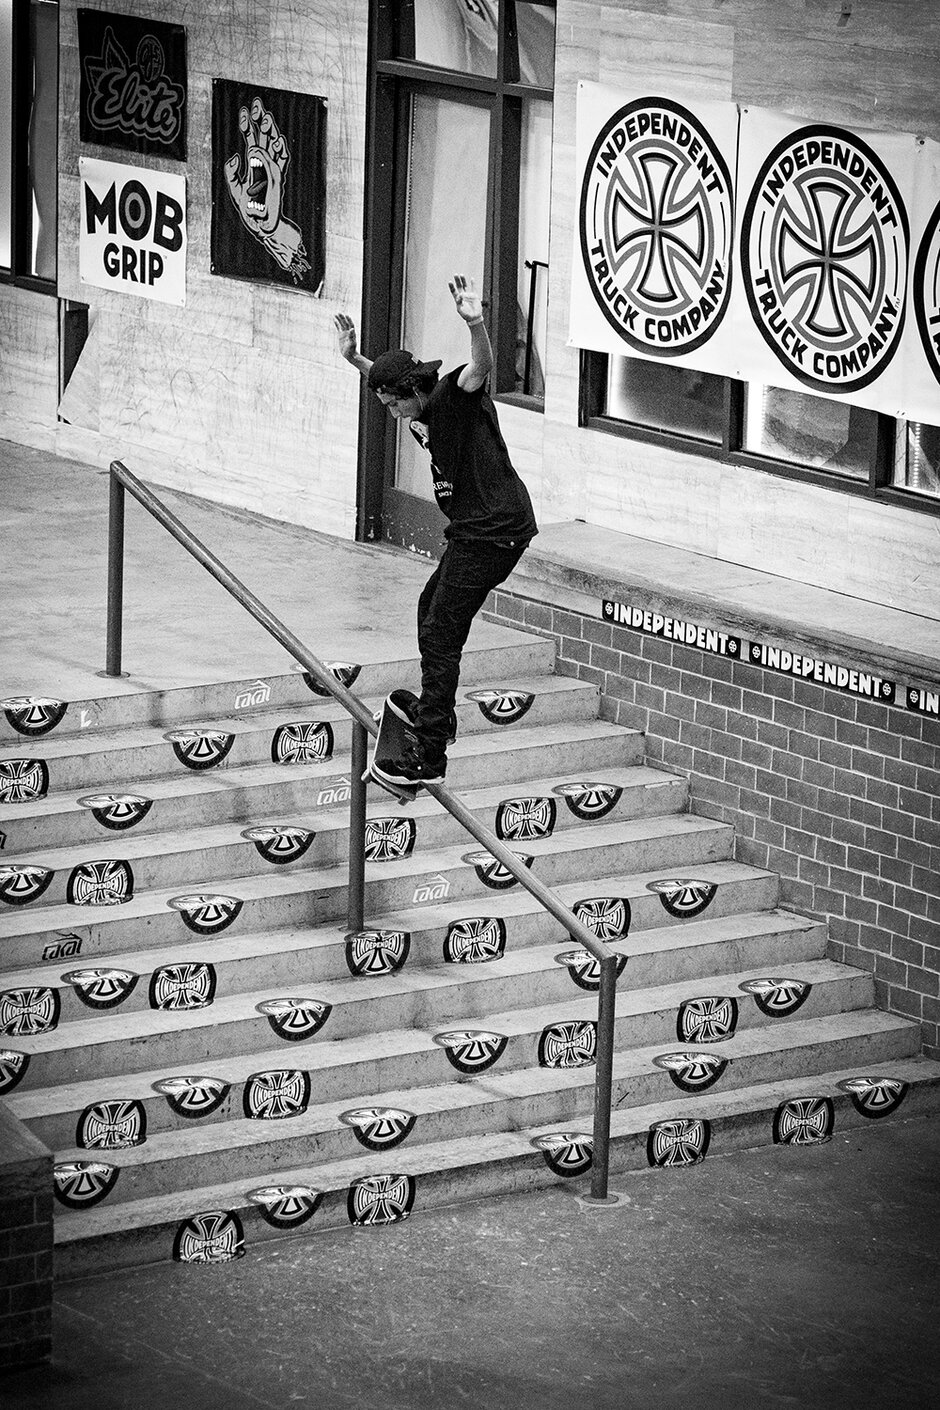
[{"left": 488, "top": 591, "right": 940, "bottom": 1058}]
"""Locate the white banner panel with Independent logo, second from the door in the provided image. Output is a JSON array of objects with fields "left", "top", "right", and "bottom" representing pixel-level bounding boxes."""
[{"left": 731, "top": 107, "right": 924, "bottom": 420}]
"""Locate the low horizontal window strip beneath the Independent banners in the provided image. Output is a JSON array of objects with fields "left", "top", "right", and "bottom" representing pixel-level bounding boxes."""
[{"left": 581, "top": 353, "right": 940, "bottom": 512}]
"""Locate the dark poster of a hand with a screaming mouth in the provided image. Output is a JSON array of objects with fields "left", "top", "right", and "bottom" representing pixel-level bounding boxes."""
[{"left": 211, "top": 79, "right": 327, "bottom": 293}]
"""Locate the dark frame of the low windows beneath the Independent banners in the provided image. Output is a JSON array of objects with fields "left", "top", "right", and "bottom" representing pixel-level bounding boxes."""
[{"left": 578, "top": 348, "right": 940, "bottom": 517}]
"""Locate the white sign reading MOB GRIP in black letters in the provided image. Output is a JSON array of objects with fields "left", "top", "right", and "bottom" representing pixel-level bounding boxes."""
[{"left": 79, "top": 157, "right": 186, "bottom": 305}]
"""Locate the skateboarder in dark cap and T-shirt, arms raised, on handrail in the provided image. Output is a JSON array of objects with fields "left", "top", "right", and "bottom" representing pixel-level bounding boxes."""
[{"left": 335, "top": 274, "right": 538, "bottom": 784}]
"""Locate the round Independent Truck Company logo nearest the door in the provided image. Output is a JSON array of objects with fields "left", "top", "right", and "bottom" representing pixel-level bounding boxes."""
[{"left": 581, "top": 97, "right": 734, "bottom": 357}]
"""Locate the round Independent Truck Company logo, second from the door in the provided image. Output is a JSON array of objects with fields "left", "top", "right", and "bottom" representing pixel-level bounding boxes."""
[{"left": 741, "top": 127, "right": 909, "bottom": 392}]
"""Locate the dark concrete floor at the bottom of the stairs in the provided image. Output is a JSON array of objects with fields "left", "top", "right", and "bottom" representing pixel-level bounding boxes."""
[{"left": 0, "top": 1117, "right": 940, "bottom": 1410}]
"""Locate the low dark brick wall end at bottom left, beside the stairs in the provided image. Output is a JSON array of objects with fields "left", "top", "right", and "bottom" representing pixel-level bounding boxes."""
[{"left": 0, "top": 1101, "right": 52, "bottom": 1364}]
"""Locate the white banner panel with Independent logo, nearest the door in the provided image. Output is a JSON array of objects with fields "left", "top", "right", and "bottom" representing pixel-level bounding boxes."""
[{"left": 569, "top": 83, "right": 737, "bottom": 369}]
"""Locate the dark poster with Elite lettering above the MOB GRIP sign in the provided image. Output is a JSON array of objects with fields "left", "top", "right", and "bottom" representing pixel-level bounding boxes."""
[{"left": 78, "top": 10, "right": 186, "bottom": 162}]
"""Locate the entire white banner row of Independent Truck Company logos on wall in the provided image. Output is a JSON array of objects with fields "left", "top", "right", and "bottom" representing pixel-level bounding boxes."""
[{"left": 569, "top": 83, "right": 940, "bottom": 424}]
